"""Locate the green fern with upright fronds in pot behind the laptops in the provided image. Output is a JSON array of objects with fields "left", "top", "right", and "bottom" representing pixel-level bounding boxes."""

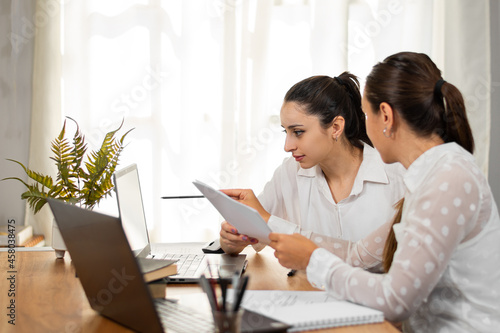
[{"left": 2, "top": 117, "right": 132, "bottom": 214}]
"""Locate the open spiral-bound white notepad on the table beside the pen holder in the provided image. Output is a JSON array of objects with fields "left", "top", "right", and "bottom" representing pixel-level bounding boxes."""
[{"left": 230, "top": 290, "right": 384, "bottom": 332}]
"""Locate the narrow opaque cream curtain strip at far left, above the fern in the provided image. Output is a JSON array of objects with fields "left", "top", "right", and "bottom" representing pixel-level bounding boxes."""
[{"left": 23, "top": 0, "right": 62, "bottom": 240}]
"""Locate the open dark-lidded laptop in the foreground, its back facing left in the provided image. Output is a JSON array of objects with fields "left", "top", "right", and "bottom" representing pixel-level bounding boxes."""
[{"left": 48, "top": 199, "right": 289, "bottom": 333}]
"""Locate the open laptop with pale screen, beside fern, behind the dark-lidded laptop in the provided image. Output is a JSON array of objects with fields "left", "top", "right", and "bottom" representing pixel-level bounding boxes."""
[{"left": 113, "top": 164, "right": 246, "bottom": 283}]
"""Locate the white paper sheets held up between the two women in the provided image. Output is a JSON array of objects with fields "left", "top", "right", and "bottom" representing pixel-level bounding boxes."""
[{"left": 193, "top": 180, "right": 271, "bottom": 245}]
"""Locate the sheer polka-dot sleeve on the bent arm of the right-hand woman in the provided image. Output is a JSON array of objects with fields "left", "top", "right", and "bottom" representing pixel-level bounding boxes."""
[{"left": 307, "top": 165, "right": 481, "bottom": 321}]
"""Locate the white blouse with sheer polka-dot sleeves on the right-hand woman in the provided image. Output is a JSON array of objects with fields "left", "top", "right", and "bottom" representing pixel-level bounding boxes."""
[{"left": 307, "top": 143, "right": 500, "bottom": 332}]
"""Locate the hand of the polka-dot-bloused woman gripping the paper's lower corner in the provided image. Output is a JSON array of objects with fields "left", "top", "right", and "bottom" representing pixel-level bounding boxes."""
[{"left": 269, "top": 232, "right": 318, "bottom": 270}]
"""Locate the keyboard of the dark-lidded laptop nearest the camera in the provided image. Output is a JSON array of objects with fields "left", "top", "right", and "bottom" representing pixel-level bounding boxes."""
[{"left": 155, "top": 298, "right": 214, "bottom": 333}]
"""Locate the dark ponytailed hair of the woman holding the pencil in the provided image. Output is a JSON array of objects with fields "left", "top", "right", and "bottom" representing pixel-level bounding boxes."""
[{"left": 285, "top": 72, "right": 373, "bottom": 148}]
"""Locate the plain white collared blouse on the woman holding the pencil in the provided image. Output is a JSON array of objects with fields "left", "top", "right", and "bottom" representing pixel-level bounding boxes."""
[{"left": 256, "top": 144, "right": 405, "bottom": 248}]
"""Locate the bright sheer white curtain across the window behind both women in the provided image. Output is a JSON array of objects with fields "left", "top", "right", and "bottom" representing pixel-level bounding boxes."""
[{"left": 25, "top": 0, "right": 491, "bottom": 241}]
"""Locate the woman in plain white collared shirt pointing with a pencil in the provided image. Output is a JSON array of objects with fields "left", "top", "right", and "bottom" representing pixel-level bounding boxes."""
[{"left": 220, "top": 72, "right": 404, "bottom": 261}]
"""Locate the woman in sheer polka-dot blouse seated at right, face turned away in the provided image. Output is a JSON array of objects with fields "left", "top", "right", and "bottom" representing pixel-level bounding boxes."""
[{"left": 270, "top": 52, "right": 500, "bottom": 332}]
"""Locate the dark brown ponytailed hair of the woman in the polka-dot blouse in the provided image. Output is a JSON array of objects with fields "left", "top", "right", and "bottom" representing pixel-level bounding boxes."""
[{"left": 365, "top": 52, "right": 474, "bottom": 271}]
